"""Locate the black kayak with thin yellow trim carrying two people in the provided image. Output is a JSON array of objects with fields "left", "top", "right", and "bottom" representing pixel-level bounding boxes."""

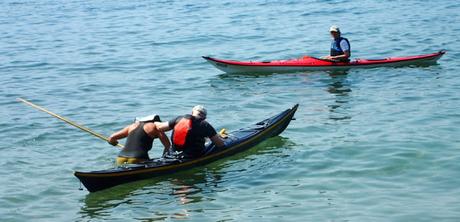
[{"left": 74, "top": 105, "right": 298, "bottom": 192}]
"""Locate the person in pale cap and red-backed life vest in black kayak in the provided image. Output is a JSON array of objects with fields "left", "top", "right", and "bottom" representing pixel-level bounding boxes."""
[{"left": 158, "top": 105, "right": 224, "bottom": 158}]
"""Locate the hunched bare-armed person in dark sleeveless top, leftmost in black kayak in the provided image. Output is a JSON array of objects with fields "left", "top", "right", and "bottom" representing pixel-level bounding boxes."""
[{"left": 108, "top": 115, "right": 171, "bottom": 165}]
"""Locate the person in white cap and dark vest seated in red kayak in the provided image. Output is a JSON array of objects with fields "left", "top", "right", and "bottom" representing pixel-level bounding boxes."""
[{"left": 322, "top": 25, "right": 351, "bottom": 62}]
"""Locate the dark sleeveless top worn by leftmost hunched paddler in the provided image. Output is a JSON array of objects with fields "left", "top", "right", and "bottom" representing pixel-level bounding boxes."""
[{"left": 118, "top": 122, "right": 153, "bottom": 159}]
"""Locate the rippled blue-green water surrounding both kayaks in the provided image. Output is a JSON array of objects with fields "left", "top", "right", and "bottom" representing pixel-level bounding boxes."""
[{"left": 0, "top": 0, "right": 460, "bottom": 221}]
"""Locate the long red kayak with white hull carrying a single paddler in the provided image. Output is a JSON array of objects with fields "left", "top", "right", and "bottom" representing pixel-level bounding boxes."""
[{"left": 203, "top": 50, "right": 446, "bottom": 73}]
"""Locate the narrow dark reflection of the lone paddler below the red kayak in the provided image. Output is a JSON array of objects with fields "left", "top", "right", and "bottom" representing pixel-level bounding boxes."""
[{"left": 327, "top": 71, "right": 351, "bottom": 121}]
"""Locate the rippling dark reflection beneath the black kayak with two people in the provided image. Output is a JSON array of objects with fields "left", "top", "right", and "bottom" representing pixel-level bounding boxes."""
[{"left": 79, "top": 136, "right": 292, "bottom": 221}]
